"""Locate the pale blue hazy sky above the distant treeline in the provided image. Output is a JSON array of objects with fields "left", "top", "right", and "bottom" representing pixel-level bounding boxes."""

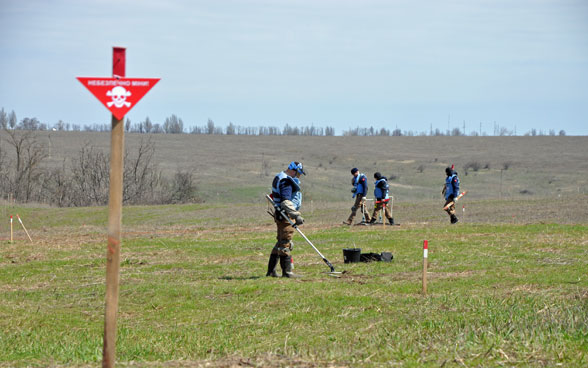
[{"left": 0, "top": 0, "right": 588, "bottom": 135}]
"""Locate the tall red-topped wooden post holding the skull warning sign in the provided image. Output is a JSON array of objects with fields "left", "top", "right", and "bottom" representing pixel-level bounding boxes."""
[{"left": 102, "top": 47, "right": 126, "bottom": 368}]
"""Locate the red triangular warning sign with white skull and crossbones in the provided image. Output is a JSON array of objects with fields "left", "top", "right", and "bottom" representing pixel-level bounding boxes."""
[{"left": 78, "top": 77, "right": 159, "bottom": 120}]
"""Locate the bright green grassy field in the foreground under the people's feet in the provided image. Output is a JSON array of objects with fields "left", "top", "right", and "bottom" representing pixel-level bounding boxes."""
[{"left": 0, "top": 194, "right": 588, "bottom": 367}]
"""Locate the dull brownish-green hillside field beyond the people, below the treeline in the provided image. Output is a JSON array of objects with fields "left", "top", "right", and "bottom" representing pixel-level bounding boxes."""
[{"left": 17, "top": 131, "right": 588, "bottom": 203}]
